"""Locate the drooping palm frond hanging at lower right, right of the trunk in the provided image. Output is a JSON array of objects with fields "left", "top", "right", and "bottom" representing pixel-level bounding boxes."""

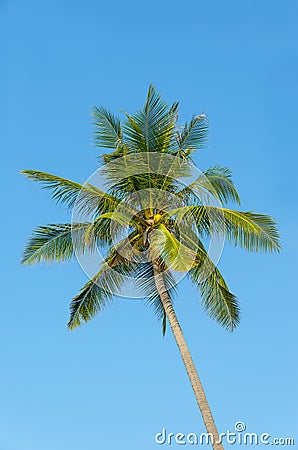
[{"left": 189, "top": 239, "right": 240, "bottom": 331}]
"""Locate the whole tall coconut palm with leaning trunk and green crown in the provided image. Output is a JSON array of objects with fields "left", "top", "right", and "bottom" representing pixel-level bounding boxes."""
[{"left": 22, "top": 86, "right": 280, "bottom": 449}]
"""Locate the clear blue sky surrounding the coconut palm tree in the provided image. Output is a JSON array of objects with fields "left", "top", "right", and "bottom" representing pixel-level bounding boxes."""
[{"left": 0, "top": 0, "right": 298, "bottom": 450}]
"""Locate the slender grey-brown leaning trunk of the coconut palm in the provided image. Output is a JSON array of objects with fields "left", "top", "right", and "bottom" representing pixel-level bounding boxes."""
[{"left": 153, "top": 261, "right": 223, "bottom": 450}]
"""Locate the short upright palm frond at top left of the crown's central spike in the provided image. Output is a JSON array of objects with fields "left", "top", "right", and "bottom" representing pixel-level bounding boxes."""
[{"left": 92, "top": 106, "right": 123, "bottom": 149}]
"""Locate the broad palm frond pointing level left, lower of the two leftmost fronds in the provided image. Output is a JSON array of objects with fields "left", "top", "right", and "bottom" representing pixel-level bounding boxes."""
[{"left": 22, "top": 223, "right": 95, "bottom": 265}]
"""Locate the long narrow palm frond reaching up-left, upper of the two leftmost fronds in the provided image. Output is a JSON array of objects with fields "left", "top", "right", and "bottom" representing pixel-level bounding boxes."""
[{"left": 21, "top": 170, "right": 119, "bottom": 213}]
